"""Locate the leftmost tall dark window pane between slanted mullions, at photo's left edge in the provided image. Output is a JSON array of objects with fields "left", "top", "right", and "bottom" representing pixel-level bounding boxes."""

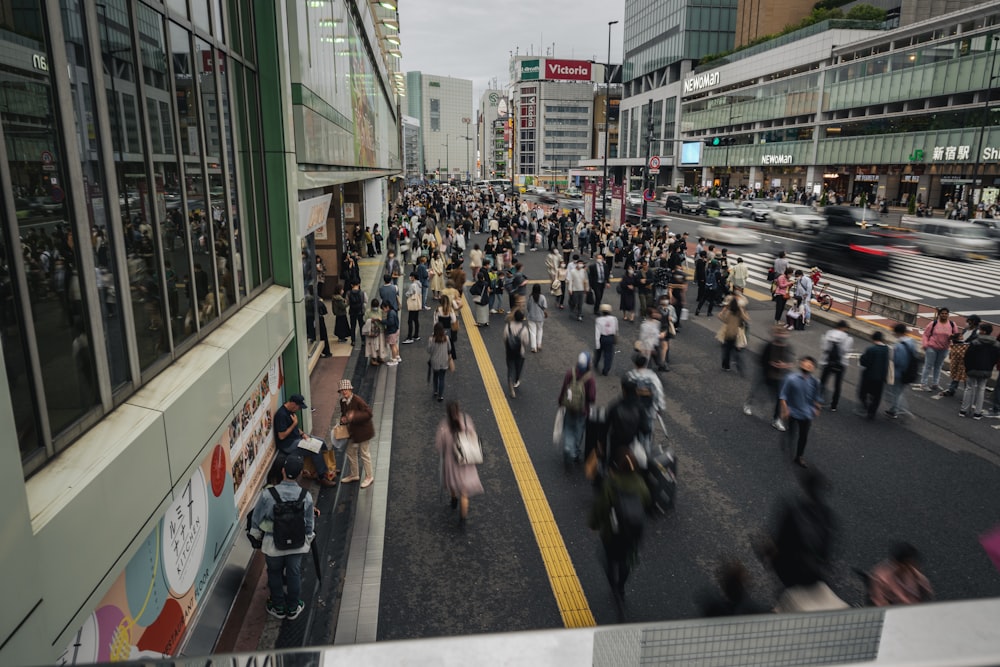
[{"left": 0, "top": 2, "right": 99, "bottom": 440}]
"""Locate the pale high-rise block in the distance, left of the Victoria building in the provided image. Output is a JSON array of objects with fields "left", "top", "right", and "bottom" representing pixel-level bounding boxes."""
[{"left": 406, "top": 72, "right": 476, "bottom": 180}]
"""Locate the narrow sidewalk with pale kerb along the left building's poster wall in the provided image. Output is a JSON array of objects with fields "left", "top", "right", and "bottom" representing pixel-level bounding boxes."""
[{"left": 213, "top": 256, "right": 395, "bottom": 653}]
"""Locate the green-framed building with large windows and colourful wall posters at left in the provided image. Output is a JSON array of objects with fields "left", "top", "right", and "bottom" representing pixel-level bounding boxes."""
[{"left": 0, "top": 0, "right": 400, "bottom": 665}]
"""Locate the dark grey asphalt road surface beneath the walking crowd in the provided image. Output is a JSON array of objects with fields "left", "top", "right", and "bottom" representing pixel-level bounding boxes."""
[{"left": 378, "top": 239, "right": 1000, "bottom": 640}]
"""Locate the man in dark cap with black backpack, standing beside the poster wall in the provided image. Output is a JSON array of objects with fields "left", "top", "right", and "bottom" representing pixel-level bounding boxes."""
[{"left": 249, "top": 454, "right": 316, "bottom": 619}]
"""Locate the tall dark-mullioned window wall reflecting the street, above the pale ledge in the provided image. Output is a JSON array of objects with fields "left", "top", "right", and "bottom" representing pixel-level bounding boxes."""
[{"left": 0, "top": 0, "right": 271, "bottom": 474}]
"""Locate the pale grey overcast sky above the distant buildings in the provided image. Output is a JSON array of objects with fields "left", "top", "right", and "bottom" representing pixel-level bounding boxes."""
[{"left": 399, "top": 0, "right": 625, "bottom": 107}]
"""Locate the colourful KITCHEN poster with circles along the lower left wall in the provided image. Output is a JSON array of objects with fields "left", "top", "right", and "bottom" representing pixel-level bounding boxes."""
[{"left": 58, "top": 358, "right": 284, "bottom": 665}]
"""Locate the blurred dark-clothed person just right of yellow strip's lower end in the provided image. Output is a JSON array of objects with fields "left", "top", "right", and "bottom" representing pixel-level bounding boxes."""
[{"left": 588, "top": 426, "right": 652, "bottom": 614}]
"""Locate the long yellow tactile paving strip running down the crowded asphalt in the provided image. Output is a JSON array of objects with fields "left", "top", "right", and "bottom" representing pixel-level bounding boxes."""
[{"left": 462, "top": 303, "right": 596, "bottom": 628}]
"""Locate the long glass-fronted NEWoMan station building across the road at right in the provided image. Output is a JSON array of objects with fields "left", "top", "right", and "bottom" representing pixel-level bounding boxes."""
[{"left": 681, "top": 2, "right": 1000, "bottom": 207}]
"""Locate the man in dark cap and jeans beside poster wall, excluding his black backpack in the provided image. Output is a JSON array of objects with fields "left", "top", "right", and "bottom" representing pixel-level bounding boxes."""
[{"left": 250, "top": 454, "right": 314, "bottom": 619}]
